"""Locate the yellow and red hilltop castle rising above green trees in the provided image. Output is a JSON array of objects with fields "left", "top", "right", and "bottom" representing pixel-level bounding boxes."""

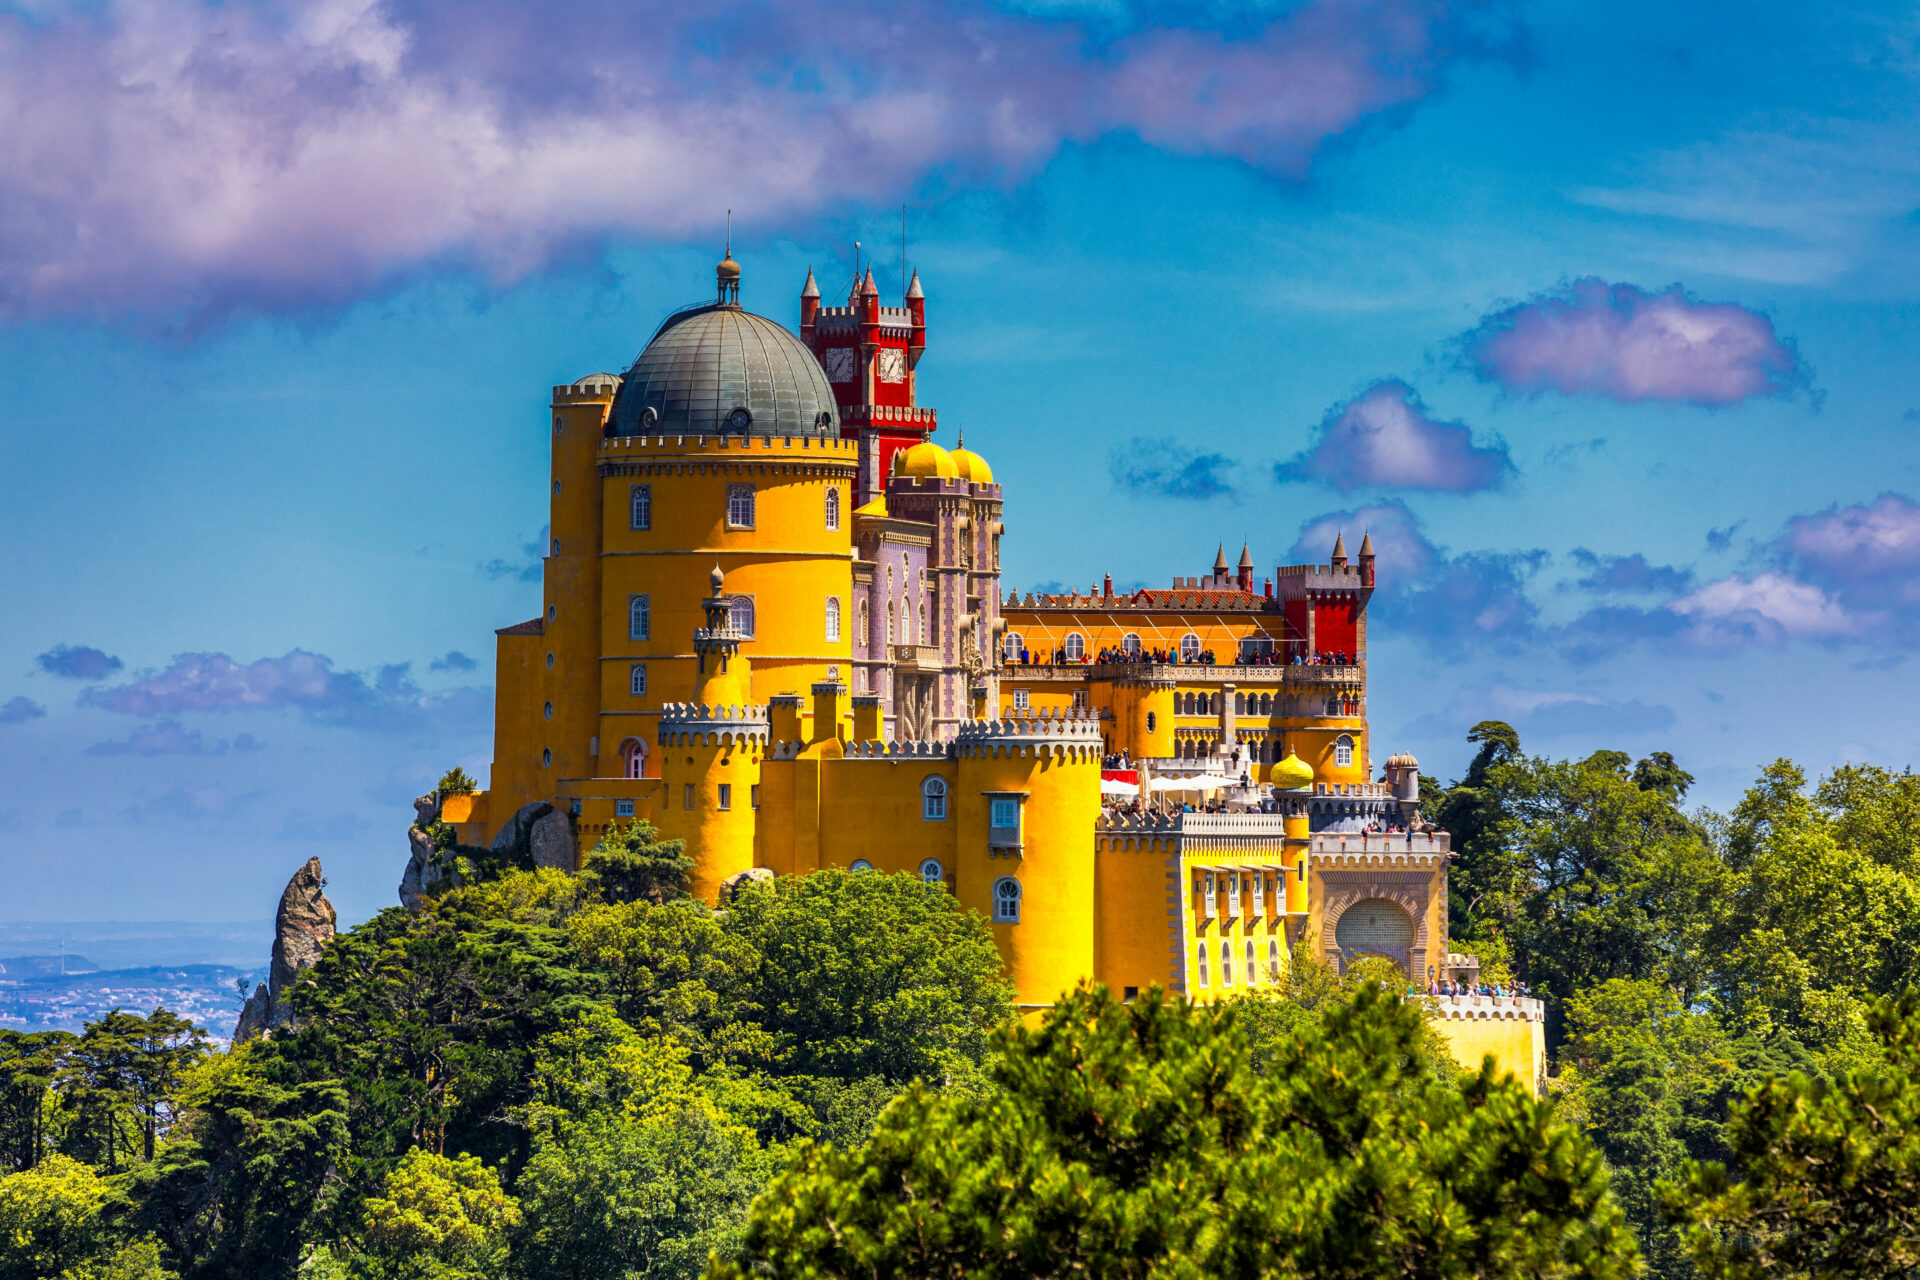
[{"left": 445, "top": 253, "right": 1544, "bottom": 1082}]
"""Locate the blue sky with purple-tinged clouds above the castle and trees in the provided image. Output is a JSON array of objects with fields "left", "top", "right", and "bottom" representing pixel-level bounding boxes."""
[{"left": 0, "top": 0, "right": 1920, "bottom": 919}]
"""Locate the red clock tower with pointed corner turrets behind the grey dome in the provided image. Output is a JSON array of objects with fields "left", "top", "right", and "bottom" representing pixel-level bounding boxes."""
[{"left": 801, "top": 267, "right": 937, "bottom": 507}]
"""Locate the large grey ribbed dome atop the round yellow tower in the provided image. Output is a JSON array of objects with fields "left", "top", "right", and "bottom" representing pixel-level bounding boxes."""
[{"left": 609, "top": 303, "right": 839, "bottom": 436}]
